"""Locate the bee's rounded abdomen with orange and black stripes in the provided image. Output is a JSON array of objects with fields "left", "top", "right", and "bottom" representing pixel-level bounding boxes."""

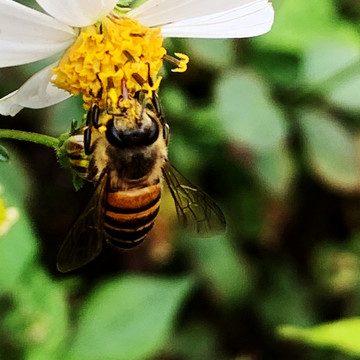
[{"left": 104, "top": 183, "right": 161, "bottom": 248}]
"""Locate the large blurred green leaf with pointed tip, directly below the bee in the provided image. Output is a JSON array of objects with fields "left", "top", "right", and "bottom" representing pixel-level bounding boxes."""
[{"left": 66, "top": 276, "right": 192, "bottom": 360}]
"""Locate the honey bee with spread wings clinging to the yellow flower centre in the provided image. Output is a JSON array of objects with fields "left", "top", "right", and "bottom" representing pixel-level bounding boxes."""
[{"left": 57, "top": 88, "right": 225, "bottom": 272}]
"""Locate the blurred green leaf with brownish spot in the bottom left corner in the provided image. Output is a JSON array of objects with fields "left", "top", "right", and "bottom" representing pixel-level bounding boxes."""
[{"left": 1, "top": 266, "right": 68, "bottom": 360}]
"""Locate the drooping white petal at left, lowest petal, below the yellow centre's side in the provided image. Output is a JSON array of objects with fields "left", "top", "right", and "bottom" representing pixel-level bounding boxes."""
[{"left": 0, "top": 63, "right": 71, "bottom": 116}]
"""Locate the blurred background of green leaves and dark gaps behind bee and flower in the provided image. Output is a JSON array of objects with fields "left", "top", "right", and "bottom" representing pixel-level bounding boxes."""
[{"left": 0, "top": 0, "right": 360, "bottom": 360}]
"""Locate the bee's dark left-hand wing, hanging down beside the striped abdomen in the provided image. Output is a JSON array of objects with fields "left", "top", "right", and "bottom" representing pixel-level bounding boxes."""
[{"left": 57, "top": 173, "right": 108, "bottom": 272}]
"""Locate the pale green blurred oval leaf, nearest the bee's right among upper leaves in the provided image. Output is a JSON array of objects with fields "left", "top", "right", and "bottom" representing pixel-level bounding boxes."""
[{"left": 216, "top": 70, "right": 287, "bottom": 151}]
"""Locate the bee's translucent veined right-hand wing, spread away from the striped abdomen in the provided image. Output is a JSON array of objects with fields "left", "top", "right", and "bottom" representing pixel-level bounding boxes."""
[{"left": 162, "top": 163, "right": 226, "bottom": 236}]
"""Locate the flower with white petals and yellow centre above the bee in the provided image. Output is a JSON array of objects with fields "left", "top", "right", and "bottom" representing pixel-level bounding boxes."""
[{"left": 0, "top": 0, "right": 274, "bottom": 116}]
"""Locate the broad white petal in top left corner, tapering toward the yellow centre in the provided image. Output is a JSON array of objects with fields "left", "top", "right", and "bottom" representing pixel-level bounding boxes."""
[{"left": 0, "top": 0, "right": 75, "bottom": 67}]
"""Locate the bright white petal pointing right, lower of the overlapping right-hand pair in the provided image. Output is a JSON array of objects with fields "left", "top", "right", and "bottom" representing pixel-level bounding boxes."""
[{"left": 161, "top": 0, "right": 274, "bottom": 38}]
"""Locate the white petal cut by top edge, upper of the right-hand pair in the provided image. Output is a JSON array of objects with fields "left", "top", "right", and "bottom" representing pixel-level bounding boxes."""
[{"left": 127, "top": 0, "right": 272, "bottom": 26}]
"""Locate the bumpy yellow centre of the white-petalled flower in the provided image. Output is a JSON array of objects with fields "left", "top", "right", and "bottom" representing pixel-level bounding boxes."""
[{"left": 52, "top": 17, "right": 166, "bottom": 112}]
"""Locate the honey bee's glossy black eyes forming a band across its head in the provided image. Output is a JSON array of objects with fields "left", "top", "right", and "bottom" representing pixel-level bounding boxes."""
[{"left": 106, "top": 119, "right": 159, "bottom": 148}]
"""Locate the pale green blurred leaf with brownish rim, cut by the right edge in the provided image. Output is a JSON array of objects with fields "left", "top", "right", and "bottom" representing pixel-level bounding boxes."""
[{"left": 299, "top": 109, "right": 360, "bottom": 191}]
